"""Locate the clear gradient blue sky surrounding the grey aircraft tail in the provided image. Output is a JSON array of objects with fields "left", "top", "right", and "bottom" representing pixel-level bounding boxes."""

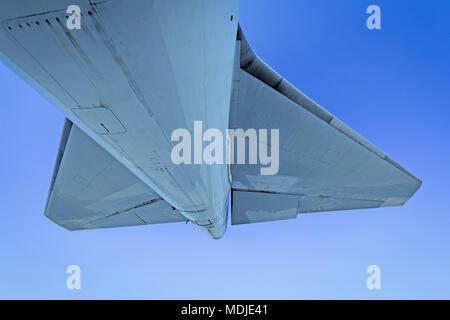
[{"left": 0, "top": 0, "right": 450, "bottom": 299}]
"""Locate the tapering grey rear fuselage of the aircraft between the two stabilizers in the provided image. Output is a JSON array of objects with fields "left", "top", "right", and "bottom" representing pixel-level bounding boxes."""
[{"left": 0, "top": 0, "right": 239, "bottom": 238}]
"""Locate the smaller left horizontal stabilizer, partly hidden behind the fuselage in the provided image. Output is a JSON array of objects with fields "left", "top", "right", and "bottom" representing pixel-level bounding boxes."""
[{"left": 45, "top": 120, "right": 186, "bottom": 230}]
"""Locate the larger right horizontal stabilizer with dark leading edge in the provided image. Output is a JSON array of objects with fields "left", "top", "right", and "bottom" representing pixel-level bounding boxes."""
[{"left": 230, "top": 29, "right": 422, "bottom": 224}]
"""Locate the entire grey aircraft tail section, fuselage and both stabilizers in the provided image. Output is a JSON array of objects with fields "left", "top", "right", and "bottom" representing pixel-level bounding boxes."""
[{"left": 0, "top": 0, "right": 420, "bottom": 238}]
